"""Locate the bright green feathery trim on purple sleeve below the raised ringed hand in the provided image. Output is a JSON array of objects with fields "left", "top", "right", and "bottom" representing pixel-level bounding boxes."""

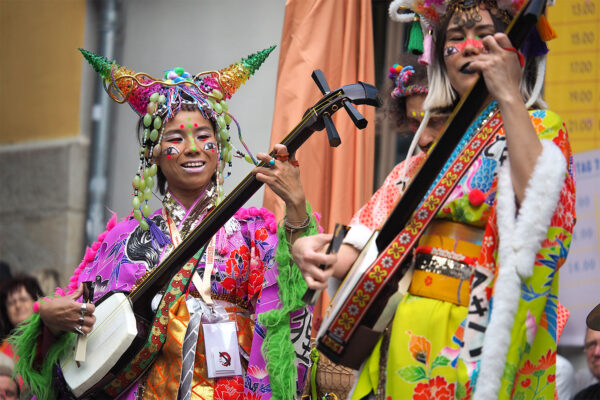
[{"left": 258, "top": 204, "right": 319, "bottom": 400}]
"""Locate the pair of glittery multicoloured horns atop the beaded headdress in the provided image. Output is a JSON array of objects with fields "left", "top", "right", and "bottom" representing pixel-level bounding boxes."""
[{"left": 79, "top": 46, "right": 275, "bottom": 116}]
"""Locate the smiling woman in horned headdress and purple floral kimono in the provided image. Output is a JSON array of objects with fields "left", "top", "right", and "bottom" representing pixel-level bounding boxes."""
[{"left": 15, "top": 47, "right": 316, "bottom": 399}]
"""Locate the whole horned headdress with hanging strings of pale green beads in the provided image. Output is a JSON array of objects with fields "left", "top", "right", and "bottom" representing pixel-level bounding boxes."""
[{"left": 79, "top": 46, "right": 275, "bottom": 231}]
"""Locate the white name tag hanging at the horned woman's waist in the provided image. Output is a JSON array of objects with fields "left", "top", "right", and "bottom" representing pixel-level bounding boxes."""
[{"left": 202, "top": 321, "right": 242, "bottom": 378}]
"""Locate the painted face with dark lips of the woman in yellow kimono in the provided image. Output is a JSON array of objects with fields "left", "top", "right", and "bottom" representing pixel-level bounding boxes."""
[{"left": 444, "top": 10, "right": 496, "bottom": 96}]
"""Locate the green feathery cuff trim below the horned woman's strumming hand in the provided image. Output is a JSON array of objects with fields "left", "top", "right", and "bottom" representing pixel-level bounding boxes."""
[{"left": 10, "top": 313, "right": 76, "bottom": 400}]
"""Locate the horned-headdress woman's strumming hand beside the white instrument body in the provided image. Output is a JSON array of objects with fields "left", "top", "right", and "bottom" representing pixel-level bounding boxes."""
[{"left": 40, "top": 283, "right": 96, "bottom": 335}]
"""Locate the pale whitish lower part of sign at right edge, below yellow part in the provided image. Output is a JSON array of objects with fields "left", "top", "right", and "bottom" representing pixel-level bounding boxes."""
[{"left": 558, "top": 148, "right": 600, "bottom": 346}]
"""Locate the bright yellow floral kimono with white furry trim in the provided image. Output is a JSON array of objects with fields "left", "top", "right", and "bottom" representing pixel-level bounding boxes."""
[{"left": 351, "top": 110, "right": 575, "bottom": 400}]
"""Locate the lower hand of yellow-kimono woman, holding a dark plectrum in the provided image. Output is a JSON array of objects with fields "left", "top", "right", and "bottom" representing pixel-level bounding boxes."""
[{"left": 292, "top": 234, "right": 337, "bottom": 290}]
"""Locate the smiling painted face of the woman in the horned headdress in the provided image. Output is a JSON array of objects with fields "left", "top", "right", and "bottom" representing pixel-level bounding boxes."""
[{"left": 158, "top": 111, "right": 219, "bottom": 197}]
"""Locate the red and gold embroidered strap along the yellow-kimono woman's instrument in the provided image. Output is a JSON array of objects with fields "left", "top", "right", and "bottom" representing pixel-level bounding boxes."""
[{"left": 320, "top": 104, "right": 502, "bottom": 354}]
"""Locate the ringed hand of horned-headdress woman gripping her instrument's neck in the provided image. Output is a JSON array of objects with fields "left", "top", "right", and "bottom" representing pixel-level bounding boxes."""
[{"left": 252, "top": 144, "right": 306, "bottom": 223}]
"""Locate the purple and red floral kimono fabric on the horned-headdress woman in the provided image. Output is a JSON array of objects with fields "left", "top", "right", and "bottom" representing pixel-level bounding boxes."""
[{"left": 72, "top": 194, "right": 311, "bottom": 399}]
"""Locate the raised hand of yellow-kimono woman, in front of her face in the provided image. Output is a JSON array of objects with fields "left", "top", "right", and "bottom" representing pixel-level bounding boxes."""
[{"left": 469, "top": 33, "right": 523, "bottom": 103}]
